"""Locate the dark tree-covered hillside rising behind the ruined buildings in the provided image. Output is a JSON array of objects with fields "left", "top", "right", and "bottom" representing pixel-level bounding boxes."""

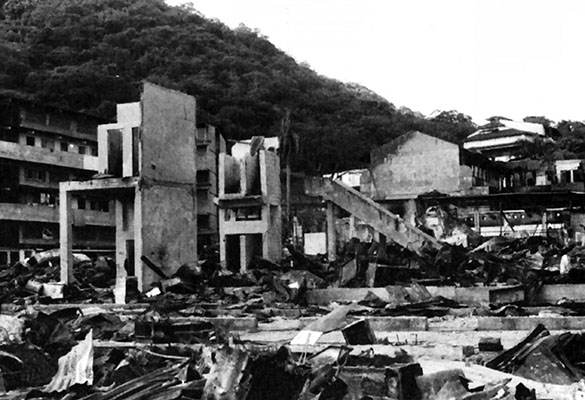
[{"left": 0, "top": 0, "right": 474, "bottom": 172}]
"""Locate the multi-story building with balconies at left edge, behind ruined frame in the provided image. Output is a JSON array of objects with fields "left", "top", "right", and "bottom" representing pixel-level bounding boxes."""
[{"left": 0, "top": 95, "right": 115, "bottom": 265}]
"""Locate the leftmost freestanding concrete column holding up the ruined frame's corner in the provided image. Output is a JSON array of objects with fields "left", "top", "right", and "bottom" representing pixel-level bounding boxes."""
[{"left": 59, "top": 185, "right": 73, "bottom": 283}]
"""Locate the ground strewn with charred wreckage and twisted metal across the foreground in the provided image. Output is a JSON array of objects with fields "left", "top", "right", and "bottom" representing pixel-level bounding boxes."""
[{"left": 0, "top": 238, "right": 585, "bottom": 400}]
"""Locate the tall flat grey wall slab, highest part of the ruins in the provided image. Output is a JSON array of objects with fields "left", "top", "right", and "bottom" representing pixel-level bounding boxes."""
[{"left": 136, "top": 83, "right": 197, "bottom": 288}]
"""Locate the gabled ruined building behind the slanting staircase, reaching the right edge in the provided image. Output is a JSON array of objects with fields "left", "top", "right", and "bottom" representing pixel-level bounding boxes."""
[{"left": 304, "top": 132, "right": 585, "bottom": 247}]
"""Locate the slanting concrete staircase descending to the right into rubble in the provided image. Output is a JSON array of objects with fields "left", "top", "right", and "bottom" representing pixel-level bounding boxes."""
[{"left": 305, "top": 178, "right": 443, "bottom": 254}]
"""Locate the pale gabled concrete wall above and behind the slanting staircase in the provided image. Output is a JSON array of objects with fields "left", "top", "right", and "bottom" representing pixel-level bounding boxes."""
[{"left": 366, "top": 132, "right": 461, "bottom": 200}]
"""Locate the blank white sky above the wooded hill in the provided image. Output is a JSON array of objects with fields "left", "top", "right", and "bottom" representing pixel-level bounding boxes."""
[{"left": 166, "top": 0, "right": 585, "bottom": 123}]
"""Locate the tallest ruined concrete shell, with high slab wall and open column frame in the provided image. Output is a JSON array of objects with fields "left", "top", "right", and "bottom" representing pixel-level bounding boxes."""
[{"left": 59, "top": 83, "right": 198, "bottom": 290}]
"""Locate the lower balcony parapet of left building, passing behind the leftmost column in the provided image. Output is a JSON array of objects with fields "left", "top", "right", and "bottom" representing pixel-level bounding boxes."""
[{"left": 0, "top": 203, "right": 116, "bottom": 226}]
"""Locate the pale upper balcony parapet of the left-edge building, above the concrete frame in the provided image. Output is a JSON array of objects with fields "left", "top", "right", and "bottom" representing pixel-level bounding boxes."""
[{"left": 0, "top": 141, "right": 98, "bottom": 171}]
